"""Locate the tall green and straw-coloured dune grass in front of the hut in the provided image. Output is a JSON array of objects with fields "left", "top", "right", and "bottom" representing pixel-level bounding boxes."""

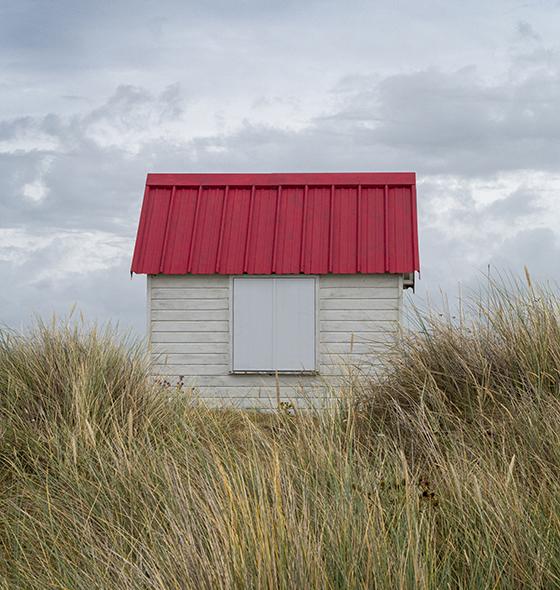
[{"left": 0, "top": 285, "right": 560, "bottom": 590}]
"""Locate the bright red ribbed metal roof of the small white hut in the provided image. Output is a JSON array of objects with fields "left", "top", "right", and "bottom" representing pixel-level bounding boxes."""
[{"left": 131, "top": 172, "right": 420, "bottom": 274}]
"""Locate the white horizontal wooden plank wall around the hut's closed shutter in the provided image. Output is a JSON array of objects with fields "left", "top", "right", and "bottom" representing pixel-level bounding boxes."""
[{"left": 148, "top": 275, "right": 403, "bottom": 408}]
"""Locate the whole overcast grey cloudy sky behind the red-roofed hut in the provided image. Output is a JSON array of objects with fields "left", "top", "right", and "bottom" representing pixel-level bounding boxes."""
[{"left": 0, "top": 0, "right": 560, "bottom": 334}]
